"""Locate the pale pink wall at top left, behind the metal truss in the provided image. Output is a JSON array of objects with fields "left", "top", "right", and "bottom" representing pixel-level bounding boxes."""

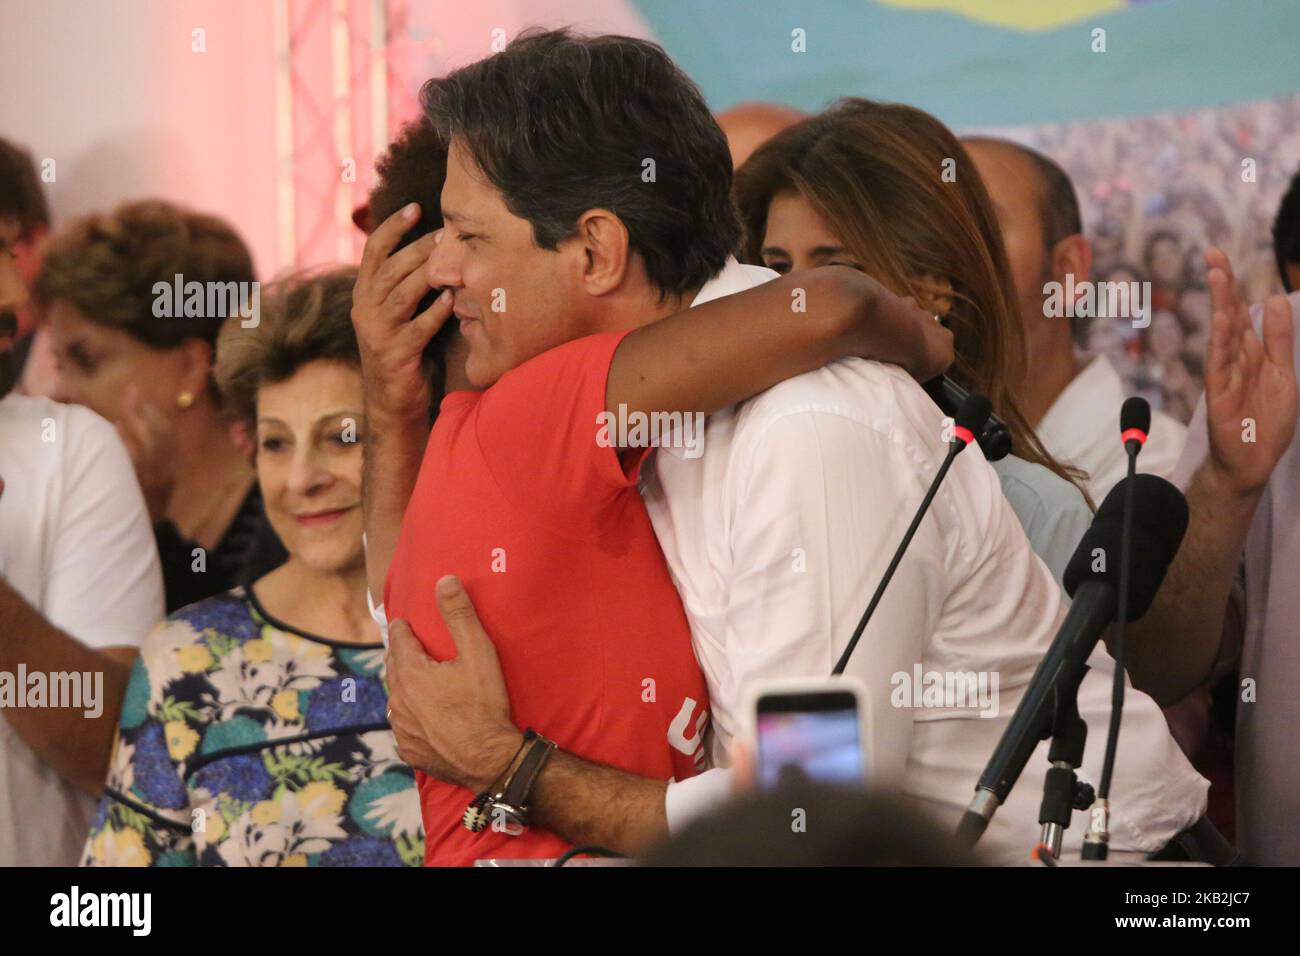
[{"left": 0, "top": 0, "right": 649, "bottom": 277}]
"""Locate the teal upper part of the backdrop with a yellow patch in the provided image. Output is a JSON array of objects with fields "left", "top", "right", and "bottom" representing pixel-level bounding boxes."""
[{"left": 633, "top": 0, "right": 1300, "bottom": 126}]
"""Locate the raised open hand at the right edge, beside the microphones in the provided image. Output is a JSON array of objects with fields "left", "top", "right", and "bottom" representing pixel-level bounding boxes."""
[{"left": 1205, "top": 248, "right": 1296, "bottom": 494}]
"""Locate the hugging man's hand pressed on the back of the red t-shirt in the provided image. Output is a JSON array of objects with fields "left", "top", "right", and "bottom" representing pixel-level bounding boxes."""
[{"left": 387, "top": 576, "right": 523, "bottom": 793}]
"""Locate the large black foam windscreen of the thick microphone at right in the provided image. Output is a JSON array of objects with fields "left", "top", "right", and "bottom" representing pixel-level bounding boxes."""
[{"left": 1063, "top": 475, "right": 1187, "bottom": 620}]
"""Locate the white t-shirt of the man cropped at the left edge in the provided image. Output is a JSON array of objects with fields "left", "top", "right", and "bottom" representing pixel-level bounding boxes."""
[{"left": 0, "top": 394, "right": 164, "bottom": 866}]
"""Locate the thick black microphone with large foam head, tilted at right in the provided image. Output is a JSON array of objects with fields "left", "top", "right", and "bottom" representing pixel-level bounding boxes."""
[{"left": 957, "top": 475, "right": 1187, "bottom": 845}]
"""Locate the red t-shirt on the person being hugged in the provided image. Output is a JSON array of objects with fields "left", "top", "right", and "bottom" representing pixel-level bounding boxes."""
[{"left": 385, "top": 333, "right": 709, "bottom": 866}]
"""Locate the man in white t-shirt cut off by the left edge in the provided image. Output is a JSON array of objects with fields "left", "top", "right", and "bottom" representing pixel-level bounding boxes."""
[{"left": 0, "top": 250, "right": 163, "bottom": 866}]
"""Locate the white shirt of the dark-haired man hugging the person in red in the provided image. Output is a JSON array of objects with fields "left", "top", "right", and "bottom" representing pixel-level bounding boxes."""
[{"left": 644, "top": 267, "right": 1209, "bottom": 862}]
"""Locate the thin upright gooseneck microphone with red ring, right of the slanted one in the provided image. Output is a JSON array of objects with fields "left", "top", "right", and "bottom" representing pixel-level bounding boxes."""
[{"left": 1083, "top": 395, "right": 1151, "bottom": 860}]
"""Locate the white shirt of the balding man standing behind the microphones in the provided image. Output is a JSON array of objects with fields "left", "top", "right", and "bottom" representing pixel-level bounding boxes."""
[{"left": 1037, "top": 355, "right": 1187, "bottom": 506}]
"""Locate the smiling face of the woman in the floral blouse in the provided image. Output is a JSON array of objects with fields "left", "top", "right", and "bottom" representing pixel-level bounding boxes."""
[{"left": 257, "top": 359, "right": 365, "bottom": 574}]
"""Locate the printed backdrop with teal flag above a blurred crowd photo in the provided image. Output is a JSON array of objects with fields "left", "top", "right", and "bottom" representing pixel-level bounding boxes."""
[{"left": 636, "top": 0, "right": 1300, "bottom": 421}]
